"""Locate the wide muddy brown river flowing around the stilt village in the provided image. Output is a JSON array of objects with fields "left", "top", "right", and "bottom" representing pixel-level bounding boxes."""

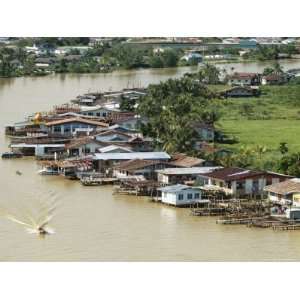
[{"left": 0, "top": 61, "right": 300, "bottom": 261}]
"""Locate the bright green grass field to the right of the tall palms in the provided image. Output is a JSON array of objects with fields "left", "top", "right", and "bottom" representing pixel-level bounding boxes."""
[{"left": 214, "top": 85, "right": 300, "bottom": 152}]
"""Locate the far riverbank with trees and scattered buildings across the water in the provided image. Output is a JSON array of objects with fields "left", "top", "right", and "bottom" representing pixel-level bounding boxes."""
[{"left": 0, "top": 37, "right": 298, "bottom": 77}]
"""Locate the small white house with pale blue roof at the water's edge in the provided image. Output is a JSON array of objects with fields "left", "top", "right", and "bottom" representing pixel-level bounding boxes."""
[{"left": 158, "top": 184, "right": 207, "bottom": 206}]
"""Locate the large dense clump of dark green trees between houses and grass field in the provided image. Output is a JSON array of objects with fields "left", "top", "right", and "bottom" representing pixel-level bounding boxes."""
[{"left": 137, "top": 77, "right": 217, "bottom": 153}]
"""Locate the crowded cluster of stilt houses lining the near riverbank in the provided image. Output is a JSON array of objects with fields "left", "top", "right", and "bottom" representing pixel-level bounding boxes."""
[{"left": 6, "top": 81, "right": 300, "bottom": 218}]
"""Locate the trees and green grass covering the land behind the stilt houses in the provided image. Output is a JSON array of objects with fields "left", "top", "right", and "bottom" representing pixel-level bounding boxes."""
[{"left": 132, "top": 70, "right": 300, "bottom": 176}]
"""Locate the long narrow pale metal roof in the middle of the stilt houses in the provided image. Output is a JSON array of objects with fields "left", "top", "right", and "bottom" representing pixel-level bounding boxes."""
[{"left": 92, "top": 152, "right": 170, "bottom": 160}]
